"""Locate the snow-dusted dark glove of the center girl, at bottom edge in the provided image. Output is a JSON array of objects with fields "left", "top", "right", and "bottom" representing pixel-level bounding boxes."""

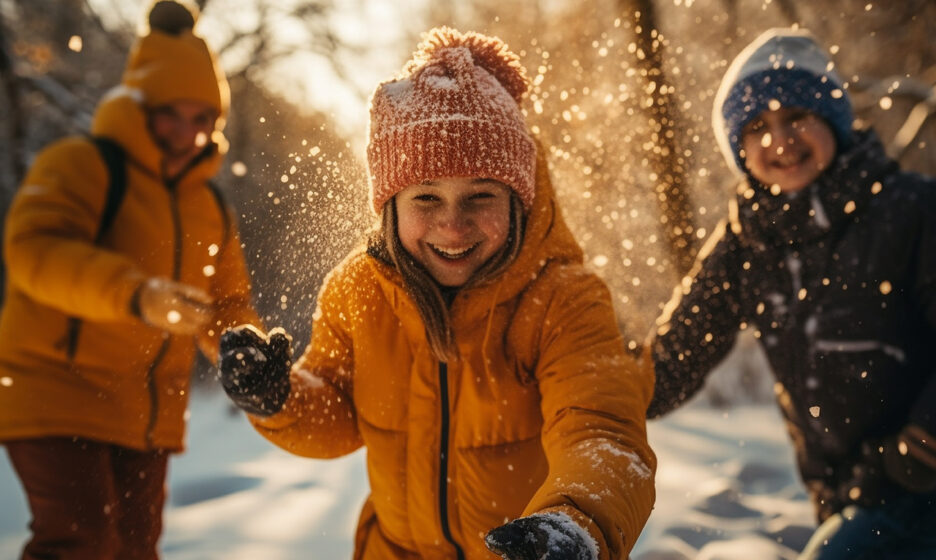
[{"left": 484, "top": 512, "right": 598, "bottom": 560}]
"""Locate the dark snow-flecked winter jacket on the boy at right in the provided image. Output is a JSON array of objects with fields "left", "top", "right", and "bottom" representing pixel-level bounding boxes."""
[{"left": 648, "top": 132, "right": 936, "bottom": 519}]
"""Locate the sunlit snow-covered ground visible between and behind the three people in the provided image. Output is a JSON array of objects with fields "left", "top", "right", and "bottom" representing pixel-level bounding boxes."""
[{"left": 0, "top": 378, "right": 813, "bottom": 560}]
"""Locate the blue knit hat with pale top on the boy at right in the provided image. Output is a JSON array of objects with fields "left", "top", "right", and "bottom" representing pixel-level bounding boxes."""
[{"left": 712, "top": 28, "right": 854, "bottom": 170}]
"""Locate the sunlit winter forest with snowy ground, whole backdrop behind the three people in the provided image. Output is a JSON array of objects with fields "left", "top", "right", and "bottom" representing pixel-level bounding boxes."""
[{"left": 0, "top": 0, "right": 936, "bottom": 560}]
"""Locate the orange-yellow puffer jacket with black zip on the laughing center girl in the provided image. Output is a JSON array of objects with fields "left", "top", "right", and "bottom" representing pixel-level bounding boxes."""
[{"left": 251, "top": 156, "right": 656, "bottom": 560}]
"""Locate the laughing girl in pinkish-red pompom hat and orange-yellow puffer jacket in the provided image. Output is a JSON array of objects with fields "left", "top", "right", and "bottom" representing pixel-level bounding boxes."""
[{"left": 220, "top": 28, "right": 656, "bottom": 560}]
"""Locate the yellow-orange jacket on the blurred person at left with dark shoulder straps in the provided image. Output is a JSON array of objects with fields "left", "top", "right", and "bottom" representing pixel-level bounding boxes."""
[{"left": 0, "top": 86, "right": 258, "bottom": 449}]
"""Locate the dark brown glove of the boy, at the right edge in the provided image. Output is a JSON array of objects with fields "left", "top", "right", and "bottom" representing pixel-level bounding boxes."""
[{"left": 882, "top": 424, "right": 936, "bottom": 493}]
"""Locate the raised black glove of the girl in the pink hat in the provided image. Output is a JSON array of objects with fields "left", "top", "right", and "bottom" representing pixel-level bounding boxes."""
[{"left": 218, "top": 325, "right": 292, "bottom": 416}]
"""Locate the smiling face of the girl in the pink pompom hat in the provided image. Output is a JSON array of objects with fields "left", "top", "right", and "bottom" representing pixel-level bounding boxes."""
[{"left": 396, "top": 177, "right": 510, "bottom": 287}]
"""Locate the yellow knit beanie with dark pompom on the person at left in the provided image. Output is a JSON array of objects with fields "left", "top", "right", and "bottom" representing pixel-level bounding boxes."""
[{"left": 122, "top": 0, "right": 230, "bottom": 115}]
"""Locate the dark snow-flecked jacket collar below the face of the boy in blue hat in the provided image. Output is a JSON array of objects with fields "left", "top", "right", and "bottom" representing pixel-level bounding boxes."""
[{"left": 729, "top": 130, "right": 897, "bottom": 248}]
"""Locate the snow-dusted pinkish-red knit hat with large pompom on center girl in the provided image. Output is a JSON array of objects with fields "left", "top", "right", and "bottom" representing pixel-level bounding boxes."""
[{"left": 367, "top": 27, "right": 536, "bottom": 214}]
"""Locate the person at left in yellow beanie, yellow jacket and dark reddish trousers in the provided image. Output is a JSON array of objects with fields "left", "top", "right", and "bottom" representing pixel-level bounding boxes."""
[{"left": 0, "top": 2, "right": 258, "bottom": 560}]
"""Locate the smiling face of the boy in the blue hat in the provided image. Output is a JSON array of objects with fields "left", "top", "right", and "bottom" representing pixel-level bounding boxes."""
[{"left": 741, "top": 107, "right": 835, "bottom": 192}]
